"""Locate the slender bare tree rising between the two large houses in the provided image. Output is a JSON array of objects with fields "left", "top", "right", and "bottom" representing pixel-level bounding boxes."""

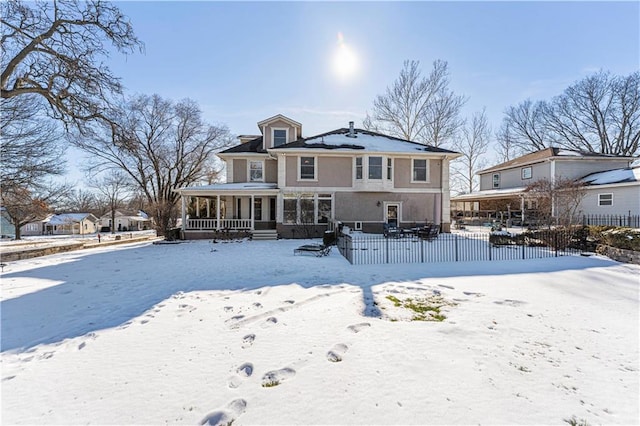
[{"left": 453, "top": 109, "right": 491, "bottom": 192}]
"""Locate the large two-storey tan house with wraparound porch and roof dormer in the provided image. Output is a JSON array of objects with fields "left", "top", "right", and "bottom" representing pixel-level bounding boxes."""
[{"left": 177, "top": 115, "right": 460, "bottom": 238}]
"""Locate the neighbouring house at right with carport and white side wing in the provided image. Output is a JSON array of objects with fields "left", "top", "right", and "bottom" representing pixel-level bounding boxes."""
[{"left": 451, "top": 148, "right": 640, "bottom": 226}]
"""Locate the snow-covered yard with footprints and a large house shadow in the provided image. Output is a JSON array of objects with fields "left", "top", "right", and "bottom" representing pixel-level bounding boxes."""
[{"left": 0, "top": 240, "right": 640, "bottom": 425}]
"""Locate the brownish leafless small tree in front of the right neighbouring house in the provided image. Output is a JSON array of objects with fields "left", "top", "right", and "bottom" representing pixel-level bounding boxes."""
[{"left": 525, "top": 178, "right": 586, "bottom": 227}]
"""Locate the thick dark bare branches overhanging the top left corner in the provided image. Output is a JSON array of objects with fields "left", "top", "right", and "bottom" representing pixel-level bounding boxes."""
[{"left": 0, "top": 0, "right": 142, "bottom": 125}]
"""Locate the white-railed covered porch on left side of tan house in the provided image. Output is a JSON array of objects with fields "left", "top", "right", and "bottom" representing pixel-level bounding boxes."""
[{"left": 177, "top": 183, "right": 278, "bottom": 239}]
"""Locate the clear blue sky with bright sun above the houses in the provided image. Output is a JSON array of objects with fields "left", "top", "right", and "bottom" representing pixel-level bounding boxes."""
[{"left": 63, "top": 1, "right": 640, "bottom": 181}]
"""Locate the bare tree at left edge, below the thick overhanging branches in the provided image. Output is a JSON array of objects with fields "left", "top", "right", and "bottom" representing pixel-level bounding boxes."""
[{"left": 0, "top": 95, "right": 64, "bottom": 191}]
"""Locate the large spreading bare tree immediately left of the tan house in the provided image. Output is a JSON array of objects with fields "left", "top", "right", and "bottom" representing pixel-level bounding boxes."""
[{"left": 72, "top": 95, "right": 228, "bottom": 235}]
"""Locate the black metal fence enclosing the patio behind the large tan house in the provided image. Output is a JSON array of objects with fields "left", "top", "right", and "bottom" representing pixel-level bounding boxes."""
[{"left": 337, "top": 230, "right": 581, "bottom": 265}]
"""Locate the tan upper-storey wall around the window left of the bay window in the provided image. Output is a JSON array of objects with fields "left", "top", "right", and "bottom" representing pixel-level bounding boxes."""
[{"left": 280, "top": 154, "right": 353, "bottom": 188}]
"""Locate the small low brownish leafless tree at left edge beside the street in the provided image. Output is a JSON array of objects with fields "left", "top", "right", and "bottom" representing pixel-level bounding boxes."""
[{"left": 2, "top": 183, "right": 71, "bottom": 240}]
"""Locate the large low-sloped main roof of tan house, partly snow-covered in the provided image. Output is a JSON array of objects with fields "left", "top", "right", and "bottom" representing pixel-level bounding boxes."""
[{"left": 269, "top": 128, "right": 458, "bottom": 154}]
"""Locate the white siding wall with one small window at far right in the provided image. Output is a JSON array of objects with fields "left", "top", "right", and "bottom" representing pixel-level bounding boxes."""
[{"left": 579, "top": 183, "right": 640, "bottom": 215}]
